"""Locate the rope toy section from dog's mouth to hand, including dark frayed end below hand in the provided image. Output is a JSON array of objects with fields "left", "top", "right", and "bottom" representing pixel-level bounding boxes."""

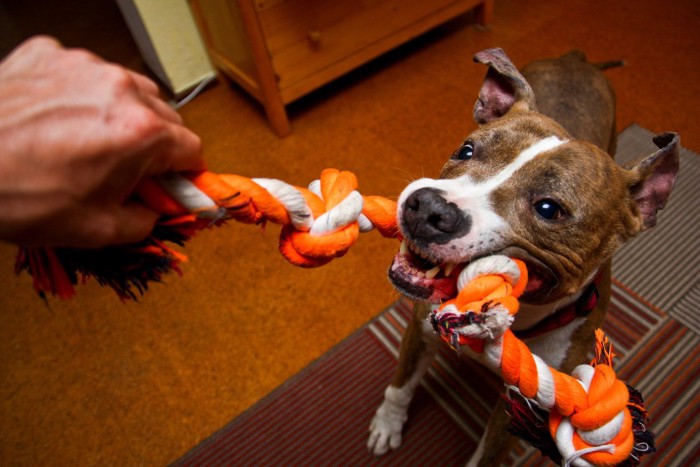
[{"left": 15, "top": 169, "right": 399, "bottom": 299}]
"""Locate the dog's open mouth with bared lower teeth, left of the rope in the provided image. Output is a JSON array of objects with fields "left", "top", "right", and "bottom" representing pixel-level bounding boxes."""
[{"left": 389, "top": 239, "right": 465, "bottom": 303}]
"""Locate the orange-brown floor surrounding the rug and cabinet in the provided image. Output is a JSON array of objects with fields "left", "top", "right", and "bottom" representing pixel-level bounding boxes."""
[{"left": 0, "top": 0, "right": 700, "bottom": 465}]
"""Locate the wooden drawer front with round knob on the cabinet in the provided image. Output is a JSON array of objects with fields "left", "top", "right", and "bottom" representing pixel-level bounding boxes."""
[{"left": 256, "top": 0, "right": 464, "bottom": 90}]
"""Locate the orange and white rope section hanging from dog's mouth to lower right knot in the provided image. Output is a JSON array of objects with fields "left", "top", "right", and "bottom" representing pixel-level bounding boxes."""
[{"left": 431, "top": 256, "right": 654, "bottom": 467}]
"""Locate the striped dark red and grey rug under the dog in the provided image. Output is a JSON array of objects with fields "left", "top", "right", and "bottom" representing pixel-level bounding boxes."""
[{"left": 174, "top": 125, "right": 700, "bottom": 466}]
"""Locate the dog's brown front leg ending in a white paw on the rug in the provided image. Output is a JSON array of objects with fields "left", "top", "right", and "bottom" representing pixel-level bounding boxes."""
[{"left": 367, "top": 302, "right": 437, "bottom": 456}]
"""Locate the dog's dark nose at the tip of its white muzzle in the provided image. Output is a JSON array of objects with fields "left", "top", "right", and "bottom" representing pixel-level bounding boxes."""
[{"left": 402, "top": 188, "right": 471, "bottom": 244}]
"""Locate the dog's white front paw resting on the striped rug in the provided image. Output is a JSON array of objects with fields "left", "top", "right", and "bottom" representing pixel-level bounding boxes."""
[{"left": 367, "top": 386, "right": 411, "bottom": 456}]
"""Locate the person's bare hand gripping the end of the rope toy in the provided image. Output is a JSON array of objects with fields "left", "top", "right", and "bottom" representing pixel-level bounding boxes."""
[{"left": 0, "top": 37, "right": 205, "bottom": 248}]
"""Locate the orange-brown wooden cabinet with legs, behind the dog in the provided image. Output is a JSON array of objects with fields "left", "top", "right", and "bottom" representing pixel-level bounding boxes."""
[{"left": 190, "top": 0, "right": 494, "bottom": 136}]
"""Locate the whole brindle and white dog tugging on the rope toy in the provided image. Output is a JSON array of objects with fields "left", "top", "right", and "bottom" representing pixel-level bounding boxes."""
[{"left": 368, "top": 49, "right": 679, "bottom": 466}]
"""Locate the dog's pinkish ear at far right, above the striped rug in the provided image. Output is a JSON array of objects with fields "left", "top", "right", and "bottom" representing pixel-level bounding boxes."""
[{"left": 627, "top": 133, "right": 680, "bottom": 230}]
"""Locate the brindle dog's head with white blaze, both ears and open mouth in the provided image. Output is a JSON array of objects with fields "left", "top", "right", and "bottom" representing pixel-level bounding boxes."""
[{"left": 389, "top": 49, "right": 679, "bottom": 304}]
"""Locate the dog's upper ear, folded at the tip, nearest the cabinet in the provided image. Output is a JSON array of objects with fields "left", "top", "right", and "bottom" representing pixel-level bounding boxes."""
[{"left": 474, "top": 48, "right": 537, "bottom": 125}]
